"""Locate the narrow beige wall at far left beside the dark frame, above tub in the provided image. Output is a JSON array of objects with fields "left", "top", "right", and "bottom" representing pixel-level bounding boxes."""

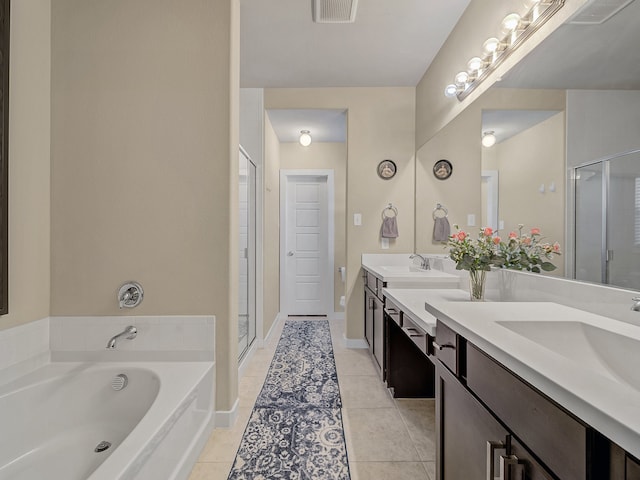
[{"left": 0, "top": 0, "right": 51, "bottom": 329}]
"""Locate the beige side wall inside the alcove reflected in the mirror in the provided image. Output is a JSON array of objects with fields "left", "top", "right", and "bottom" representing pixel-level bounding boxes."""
[{"left": 494, "top": 112, "right": 565, "bottom": 276}]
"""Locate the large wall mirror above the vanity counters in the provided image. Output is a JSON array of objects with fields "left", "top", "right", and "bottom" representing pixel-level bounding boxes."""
[{"left": 416, "top": 1, "right": 640, "bottom": 288}]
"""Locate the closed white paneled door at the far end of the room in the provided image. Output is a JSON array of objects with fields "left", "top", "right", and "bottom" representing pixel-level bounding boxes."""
[{"left": 280, "top": 172, "right": 333, "bottom": 315}]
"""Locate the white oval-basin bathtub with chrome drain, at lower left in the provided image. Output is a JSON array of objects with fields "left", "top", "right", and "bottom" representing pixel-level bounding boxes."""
[{"left": 0, "top": 362, "right": 214, "bottom": 480}]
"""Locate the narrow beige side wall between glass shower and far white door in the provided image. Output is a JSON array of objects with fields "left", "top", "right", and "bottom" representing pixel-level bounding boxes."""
[{"left": 262, "top": 114, "right": 280, "bottom": 335}]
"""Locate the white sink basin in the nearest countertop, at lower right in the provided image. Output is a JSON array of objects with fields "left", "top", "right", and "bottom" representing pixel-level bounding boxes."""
[{"left": 496, "top": 321, "right": 640, "bottom": 391}]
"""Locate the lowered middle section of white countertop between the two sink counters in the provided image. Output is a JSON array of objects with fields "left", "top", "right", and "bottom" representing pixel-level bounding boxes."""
[{"left": 382, "top": 288, "right": 469, "bottom": 337}]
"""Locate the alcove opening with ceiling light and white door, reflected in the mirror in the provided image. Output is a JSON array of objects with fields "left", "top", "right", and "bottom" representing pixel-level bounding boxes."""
[{"left": 482, "top": 110, "right": 565, "bottom": 275}]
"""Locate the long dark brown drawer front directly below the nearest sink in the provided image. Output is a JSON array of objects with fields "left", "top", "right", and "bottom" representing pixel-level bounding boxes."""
[{"left": 466, "top": 343, "right": 587, "bottom": 480}]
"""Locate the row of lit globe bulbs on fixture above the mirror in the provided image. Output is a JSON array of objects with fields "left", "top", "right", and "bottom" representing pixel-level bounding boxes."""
[{"left": 444, "top": 0, "right": 566, "bottom": 101}]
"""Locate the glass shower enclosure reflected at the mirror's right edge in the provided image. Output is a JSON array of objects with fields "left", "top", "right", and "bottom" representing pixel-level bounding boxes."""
[{"left": 574, "top": 150, "right": 640, "bottom": 290}]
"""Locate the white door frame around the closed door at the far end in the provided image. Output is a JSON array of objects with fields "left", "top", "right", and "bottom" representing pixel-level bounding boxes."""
[{"left": 279, "top": 170, "right": 335, "bottom": 318}]
